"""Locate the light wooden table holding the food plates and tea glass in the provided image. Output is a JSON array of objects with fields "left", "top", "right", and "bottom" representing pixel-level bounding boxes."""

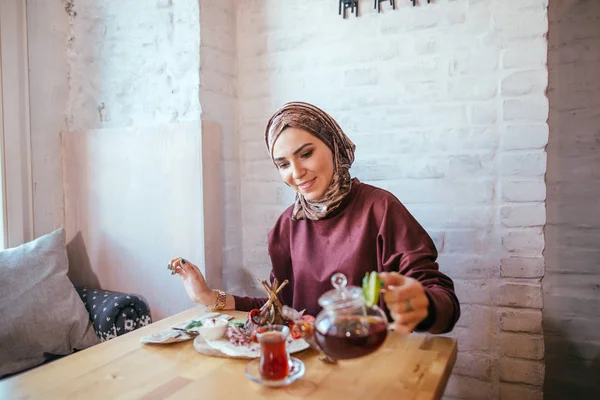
[{"left": 0, "top": 306, "right": 456, "bottom": 400}]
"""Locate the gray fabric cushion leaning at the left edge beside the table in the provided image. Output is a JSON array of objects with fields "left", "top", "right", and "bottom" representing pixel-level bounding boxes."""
[{"left": 0, "top": 228, "right": 99, "bottom": 377}]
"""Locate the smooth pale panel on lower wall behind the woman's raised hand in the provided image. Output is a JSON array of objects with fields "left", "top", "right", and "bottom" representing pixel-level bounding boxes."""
[{"left": 63, "top": 121, "right": 222, "bottom": 320}]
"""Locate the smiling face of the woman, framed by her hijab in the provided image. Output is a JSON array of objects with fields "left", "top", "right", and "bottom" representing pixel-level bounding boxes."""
[{"left": 273, "top": 128, "right": 334, "bottom": 200}]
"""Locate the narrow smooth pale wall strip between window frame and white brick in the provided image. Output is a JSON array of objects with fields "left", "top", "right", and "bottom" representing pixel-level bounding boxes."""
[{"left": 23, "top": 0, "right": 70, "bottom": 237}]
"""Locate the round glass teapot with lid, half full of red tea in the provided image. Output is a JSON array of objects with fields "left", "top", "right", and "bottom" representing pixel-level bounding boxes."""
[{"left": 294, "top": 273, "right": 388, "bottom": 363}]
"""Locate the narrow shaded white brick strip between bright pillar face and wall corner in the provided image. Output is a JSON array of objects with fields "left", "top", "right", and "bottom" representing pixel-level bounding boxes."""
[{"left": 199, "top": 0, "right": 246, "bottom": 292}]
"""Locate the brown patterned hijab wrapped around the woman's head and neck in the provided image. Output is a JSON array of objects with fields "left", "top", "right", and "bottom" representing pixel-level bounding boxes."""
[{"left": 265, "top": 102, "right": 356, "bottom": 220}]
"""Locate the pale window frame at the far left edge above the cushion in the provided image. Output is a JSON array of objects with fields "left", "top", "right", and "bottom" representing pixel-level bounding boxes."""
[{"left": 0, "top": 0, "right": 33, "bottom": 248}]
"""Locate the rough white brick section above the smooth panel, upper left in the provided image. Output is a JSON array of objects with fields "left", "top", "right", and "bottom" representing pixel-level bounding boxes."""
[{"left": 63, "top": 0, "right": 200, "bottom": 131}]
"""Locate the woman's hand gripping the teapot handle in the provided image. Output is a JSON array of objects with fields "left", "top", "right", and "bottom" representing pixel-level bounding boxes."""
[{"left": 379, "top": 272, "right": 429, "bottom": 333}]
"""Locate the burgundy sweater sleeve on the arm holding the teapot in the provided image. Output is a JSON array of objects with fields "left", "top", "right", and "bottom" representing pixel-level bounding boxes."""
[{"left": 377, "top": 195, "right": 460, "bottom": 333}]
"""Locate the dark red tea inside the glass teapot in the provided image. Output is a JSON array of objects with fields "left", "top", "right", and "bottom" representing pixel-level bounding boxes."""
[{"left": 315, "top": 316, "right": 387, "bottom": 360}]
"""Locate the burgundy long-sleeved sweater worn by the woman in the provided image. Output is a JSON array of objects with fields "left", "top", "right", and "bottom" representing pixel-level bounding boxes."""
[{"left": 234, "top": 178, "right": 460, "bottom": 333}]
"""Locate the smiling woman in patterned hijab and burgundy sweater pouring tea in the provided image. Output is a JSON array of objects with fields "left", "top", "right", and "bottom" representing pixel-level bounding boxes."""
[{"left": 169, "top": 102, "right": 460, "bottom": 333}]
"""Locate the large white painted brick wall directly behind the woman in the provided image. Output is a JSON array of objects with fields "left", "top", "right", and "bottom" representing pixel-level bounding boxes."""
[{"left": 236, "top": 0, "right": 548, "bottom": 399}]
